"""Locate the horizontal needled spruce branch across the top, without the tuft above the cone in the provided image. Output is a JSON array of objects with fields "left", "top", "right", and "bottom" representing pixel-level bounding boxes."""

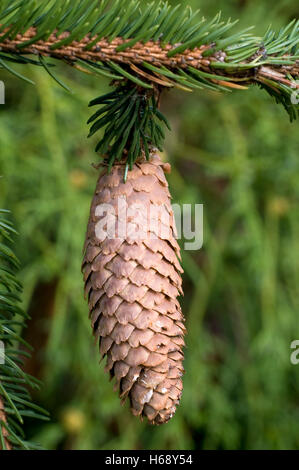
[{"left": 0, "top": 0, "right": 299, "bottom": 99}]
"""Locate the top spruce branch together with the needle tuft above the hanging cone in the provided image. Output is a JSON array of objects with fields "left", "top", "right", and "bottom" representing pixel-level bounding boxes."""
[{"left": 0, "top": 0, "right": 299, "bottom": 166}]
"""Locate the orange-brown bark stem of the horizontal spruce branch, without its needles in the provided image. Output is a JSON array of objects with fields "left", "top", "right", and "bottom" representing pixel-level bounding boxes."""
[{"left": 0, "top": 27, "right": 299, "bottom": 89}]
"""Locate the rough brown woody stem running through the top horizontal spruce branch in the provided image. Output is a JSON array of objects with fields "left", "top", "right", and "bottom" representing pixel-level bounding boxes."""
[{"left": 0, "top": 28, "right": 299, "bottom": 90}]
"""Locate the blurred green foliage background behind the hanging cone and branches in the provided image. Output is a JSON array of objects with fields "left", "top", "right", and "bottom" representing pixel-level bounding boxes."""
[{"left": 0, "top": 0, "right": 299, "bottom": 450}]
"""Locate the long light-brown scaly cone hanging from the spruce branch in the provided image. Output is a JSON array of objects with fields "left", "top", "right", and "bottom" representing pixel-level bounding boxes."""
[{"left": 82, "top": 154, "right": 185, "bottom": 424}]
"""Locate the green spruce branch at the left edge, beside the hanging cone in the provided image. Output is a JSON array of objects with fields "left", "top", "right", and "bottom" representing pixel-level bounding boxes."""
[{"left": 0, "top": 209, "right": 48, "bottom": 450}]
